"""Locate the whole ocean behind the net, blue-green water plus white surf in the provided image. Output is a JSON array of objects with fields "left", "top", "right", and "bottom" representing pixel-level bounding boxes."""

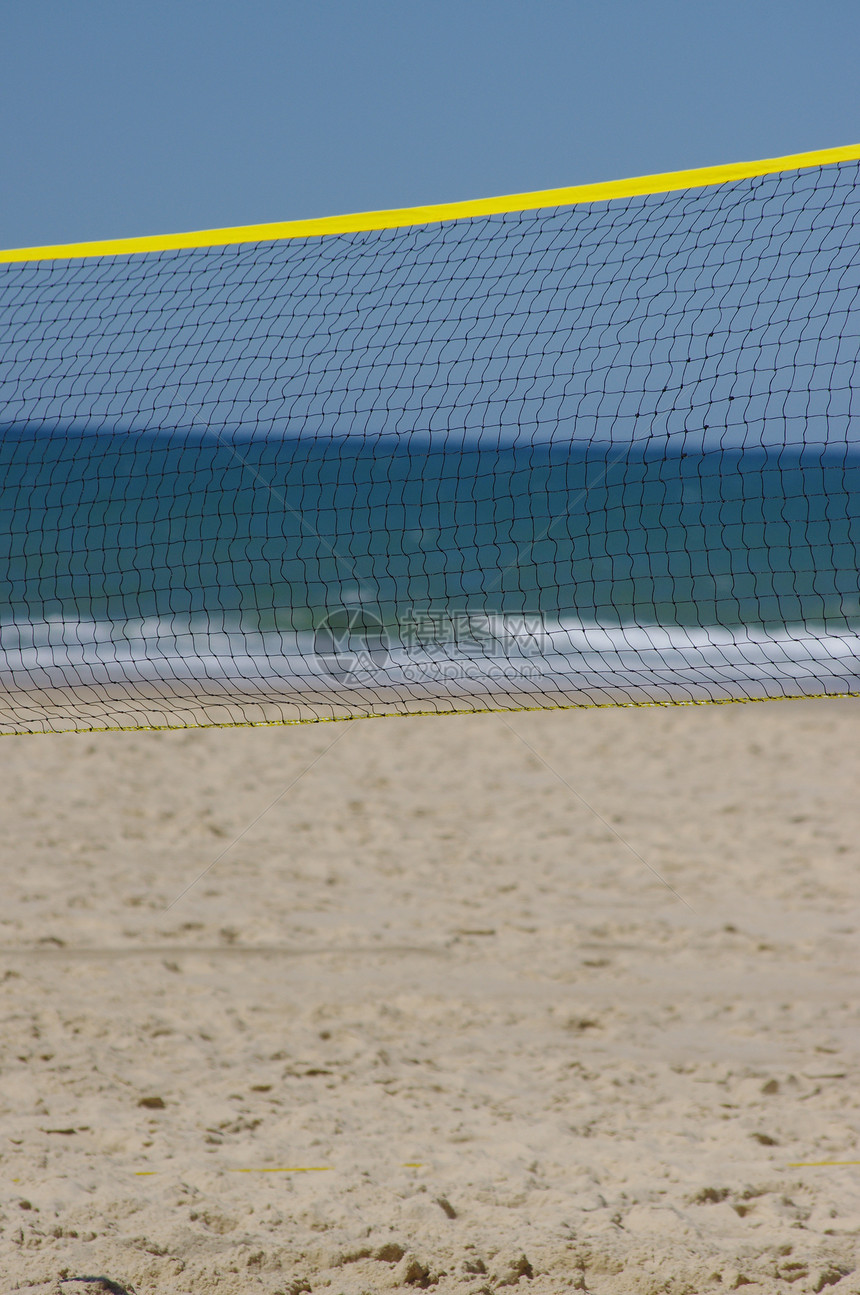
[{"left": 0, "top": 427, "right": 860, "bottom": 712}]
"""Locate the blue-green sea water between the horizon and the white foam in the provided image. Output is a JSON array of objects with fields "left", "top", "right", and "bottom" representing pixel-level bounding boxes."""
[{"left": 0, "top": 429, "right": 860, "bottom": 631}]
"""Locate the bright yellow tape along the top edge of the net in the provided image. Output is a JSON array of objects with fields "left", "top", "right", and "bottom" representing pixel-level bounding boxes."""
[{"left": 0, "top": 144, "right": 860, "bottom": 263}]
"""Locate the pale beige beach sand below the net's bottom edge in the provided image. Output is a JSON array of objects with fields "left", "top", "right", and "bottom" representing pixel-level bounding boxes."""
[{"left": 0, "top": 701, "right": 860, "bottom": 1295}]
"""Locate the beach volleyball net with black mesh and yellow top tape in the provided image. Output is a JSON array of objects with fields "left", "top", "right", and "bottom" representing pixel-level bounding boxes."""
[{"left": 0, "top": 148, "right": 860, "bottom": 733}]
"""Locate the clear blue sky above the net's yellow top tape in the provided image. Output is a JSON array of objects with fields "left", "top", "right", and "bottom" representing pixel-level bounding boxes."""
[{"left": 0, "top": 0, "right": 860, "bottom": 247}]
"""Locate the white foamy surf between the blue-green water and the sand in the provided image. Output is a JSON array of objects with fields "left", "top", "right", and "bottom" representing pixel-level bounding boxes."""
[{"left": 0, "top": 616, "right": 860, "bottom": 714}]
